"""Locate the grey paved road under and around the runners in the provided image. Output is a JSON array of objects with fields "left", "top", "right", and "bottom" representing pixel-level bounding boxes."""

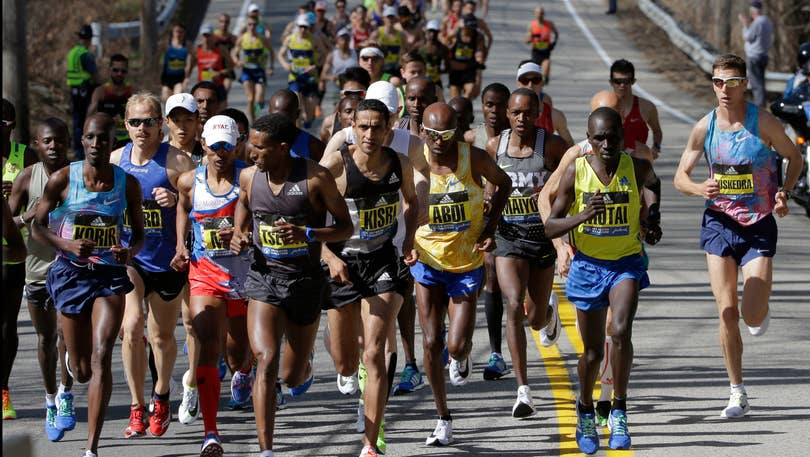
[{"left": 3, "top": 0, "right": 810, "bottom": 457}]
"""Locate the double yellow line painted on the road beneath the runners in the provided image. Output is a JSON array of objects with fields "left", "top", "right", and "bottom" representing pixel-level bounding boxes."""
[{"left": 532, "top": 284, "right": 634, "bottom": 457}]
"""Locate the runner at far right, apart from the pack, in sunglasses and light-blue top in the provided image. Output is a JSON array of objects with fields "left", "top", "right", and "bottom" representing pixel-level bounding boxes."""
[{"left": 675, "top": 54, "right": 802, "bottom": 419}]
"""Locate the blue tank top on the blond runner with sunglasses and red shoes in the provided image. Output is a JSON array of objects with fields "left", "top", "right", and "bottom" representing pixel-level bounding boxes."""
[{"left": 119, "top": 143, "right": 177, "bottom": 272}]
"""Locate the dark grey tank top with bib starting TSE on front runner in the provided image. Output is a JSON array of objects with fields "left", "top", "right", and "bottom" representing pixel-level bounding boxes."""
[{"left": 250, "top": 158, "right": 325, "bottom": 274}]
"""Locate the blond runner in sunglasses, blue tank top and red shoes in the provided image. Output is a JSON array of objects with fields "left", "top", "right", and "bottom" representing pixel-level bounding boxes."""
[{"left": 110, "top": 92, "right": 194, "bottom": 438}]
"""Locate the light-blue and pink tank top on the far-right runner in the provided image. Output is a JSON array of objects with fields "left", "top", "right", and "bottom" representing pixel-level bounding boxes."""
[{"left": 703, "top": 103, "right": 778, "bottom": 225}]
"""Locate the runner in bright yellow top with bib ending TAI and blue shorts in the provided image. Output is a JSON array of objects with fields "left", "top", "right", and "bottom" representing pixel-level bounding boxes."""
[{"left": 545, "top": 107, "right": 658, "bottom": 454}]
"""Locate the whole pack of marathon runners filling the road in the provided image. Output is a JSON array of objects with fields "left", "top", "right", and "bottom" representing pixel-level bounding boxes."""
[{"left": 2, "top": 0, "right": 802, "bottom": 457}]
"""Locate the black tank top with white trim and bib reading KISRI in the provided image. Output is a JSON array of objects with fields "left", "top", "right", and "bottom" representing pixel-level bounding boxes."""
[{"left": 329, "top": 145, "right": 402, "bottom": 255}]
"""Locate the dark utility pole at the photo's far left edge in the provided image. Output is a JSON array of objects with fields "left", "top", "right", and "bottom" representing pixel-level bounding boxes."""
[{"left": 3, "top": 0, "right": 30, "bottom": 144}]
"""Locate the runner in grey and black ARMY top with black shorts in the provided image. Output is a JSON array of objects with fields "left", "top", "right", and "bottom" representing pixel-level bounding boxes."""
[{"left": 484, "top": 88, "right": 566, "bottom": 418}]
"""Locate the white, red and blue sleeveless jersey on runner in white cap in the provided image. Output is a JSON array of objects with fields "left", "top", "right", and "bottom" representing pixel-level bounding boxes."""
[{"left": 189, "top": 160, "right": 250, "bottom": 299}]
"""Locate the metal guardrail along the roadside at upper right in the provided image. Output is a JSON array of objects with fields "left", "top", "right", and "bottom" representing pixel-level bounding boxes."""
[{"left": 638, "top": 0, "right": 793, "bottom": 92}]
